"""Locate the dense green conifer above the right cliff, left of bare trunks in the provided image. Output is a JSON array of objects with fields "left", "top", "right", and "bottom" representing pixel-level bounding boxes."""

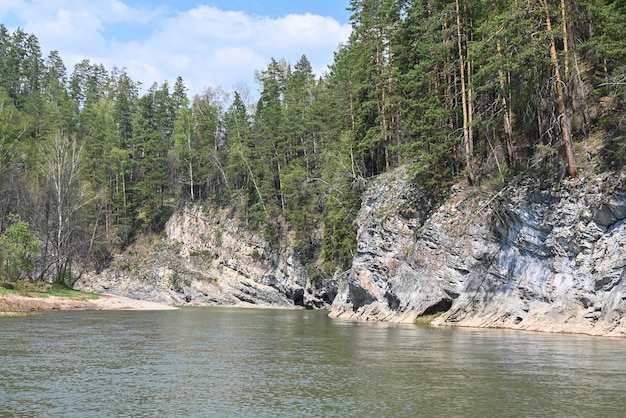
[{"left": 396, "top": 1, "right": 467, "bottom": 187}]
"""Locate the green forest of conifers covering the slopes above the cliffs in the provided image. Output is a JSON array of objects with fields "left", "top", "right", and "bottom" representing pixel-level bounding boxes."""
[{"left": 0, "top": 0, "right": 626, "bottom": 284}]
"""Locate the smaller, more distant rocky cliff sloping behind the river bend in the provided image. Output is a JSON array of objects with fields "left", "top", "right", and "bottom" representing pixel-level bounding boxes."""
[{"left": 75, "top": 206, "right": 337, "bottom": 309}]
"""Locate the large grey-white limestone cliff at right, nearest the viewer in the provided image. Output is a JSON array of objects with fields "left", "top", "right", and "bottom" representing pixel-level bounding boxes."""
[{"left": 331, "top": 172, "right": 626, "bottom": 336}]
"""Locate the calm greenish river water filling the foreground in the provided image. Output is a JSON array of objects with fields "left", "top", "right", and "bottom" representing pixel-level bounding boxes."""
[{"left": 0, "top": 308, "right": 626, "bottom": 417}]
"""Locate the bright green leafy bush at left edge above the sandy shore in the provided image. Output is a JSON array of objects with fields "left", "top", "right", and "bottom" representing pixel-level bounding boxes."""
[{"left": 0, "top": 214, "right": 41, "bottom": 280}]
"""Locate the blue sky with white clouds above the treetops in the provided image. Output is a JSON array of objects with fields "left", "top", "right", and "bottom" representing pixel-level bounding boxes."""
[{"left": 0, "top": 0, "right": 350, "bottom": 95}]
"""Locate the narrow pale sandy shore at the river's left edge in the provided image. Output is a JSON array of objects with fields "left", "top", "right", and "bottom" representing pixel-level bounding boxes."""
[{"left": 0, "top": 295, "right": 178, "bottom": 315}]
